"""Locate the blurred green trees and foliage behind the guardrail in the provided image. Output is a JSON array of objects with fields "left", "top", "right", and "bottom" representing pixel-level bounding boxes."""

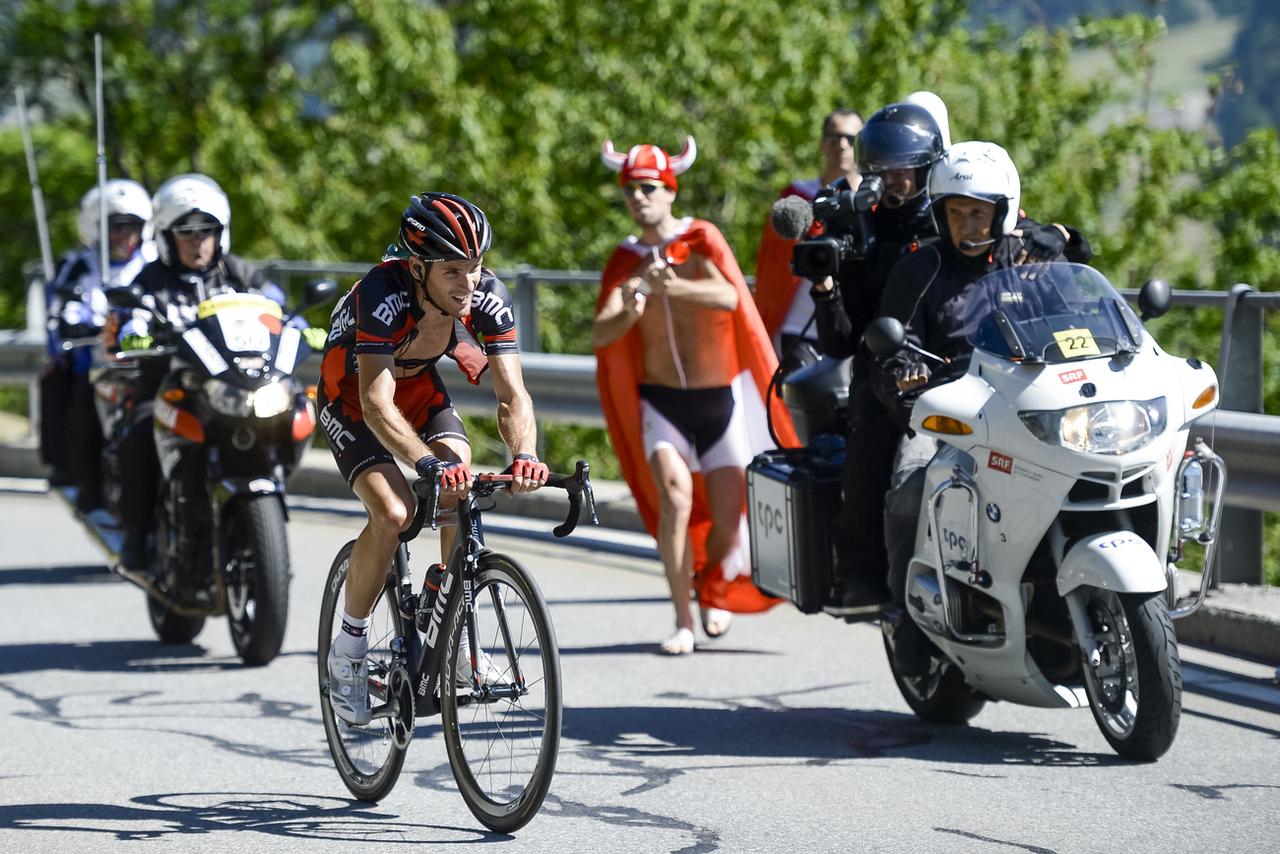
[{"left": 0, "top": 0, "right": 1280, "bottom": 579}]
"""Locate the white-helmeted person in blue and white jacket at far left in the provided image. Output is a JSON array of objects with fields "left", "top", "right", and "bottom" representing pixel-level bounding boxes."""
[{"left": 41, "top": 179, "right": 156, "bottom": 512}]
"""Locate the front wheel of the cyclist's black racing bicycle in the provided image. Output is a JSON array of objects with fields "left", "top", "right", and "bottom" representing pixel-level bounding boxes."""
[{"left": 440, "top": 553, "right": 561, "bottom": 834}]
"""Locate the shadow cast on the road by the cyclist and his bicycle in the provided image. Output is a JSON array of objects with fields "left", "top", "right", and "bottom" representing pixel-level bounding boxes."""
[{"left": 0, "top": 791, "right": 512, "bottom": 850}]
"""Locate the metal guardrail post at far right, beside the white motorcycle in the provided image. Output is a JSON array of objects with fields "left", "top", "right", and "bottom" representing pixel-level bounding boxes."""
[{"left": 1217, "top": 284, "right": 1263, "bottom": 584}]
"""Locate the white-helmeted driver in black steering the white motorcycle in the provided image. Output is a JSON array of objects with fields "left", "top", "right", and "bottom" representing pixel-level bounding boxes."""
[{"left": 874, "top": 142, "right": 1092, "bottom": 676}]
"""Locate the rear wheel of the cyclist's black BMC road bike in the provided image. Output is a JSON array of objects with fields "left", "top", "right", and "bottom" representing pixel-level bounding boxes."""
[{"left": 316, "top": 542, "right": 408, "bottom": 802}]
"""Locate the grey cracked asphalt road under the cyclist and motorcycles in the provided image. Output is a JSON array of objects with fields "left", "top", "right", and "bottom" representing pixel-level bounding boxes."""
[{"left": 0, "top": 492, "right": 1280, "bottom": 854}]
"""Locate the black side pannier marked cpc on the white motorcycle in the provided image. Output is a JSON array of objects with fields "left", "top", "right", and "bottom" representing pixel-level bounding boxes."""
[{"left": 746, "top": 449, "right": 841, "bottom": 613}]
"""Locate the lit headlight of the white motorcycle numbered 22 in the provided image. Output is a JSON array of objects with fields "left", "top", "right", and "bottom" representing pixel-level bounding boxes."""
[{"left": 1018, "top": 397, "right": 1166, "bottom": 455}]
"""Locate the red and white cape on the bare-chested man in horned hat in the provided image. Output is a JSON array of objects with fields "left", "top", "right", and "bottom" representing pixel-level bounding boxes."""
[{"left": 595, "top": 220, "right": 799, "bottom": 612}]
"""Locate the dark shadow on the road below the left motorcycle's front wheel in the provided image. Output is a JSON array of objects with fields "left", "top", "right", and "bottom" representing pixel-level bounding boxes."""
[{"left": 0, "top": 640, "right": 315, "bottom": 676}]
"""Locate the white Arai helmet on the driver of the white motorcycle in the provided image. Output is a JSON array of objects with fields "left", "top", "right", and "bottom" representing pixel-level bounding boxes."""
[{"left": 929, "top": 142, "right": 1021, "bottom": 238}]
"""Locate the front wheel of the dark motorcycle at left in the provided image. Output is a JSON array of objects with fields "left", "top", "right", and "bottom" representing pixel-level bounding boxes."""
[{"left": 223, "top": 494, "right": 289, "bottom": 667}]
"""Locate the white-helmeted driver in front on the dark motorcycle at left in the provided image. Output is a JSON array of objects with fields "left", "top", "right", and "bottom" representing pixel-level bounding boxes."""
[{"left": 118, "top": 173, "right": 283, "bottom": 571}]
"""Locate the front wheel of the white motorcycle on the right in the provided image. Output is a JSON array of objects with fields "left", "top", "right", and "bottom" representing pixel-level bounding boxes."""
[{"left": 1084, "top": 589, "right": 1183, "bottom": 762}]
